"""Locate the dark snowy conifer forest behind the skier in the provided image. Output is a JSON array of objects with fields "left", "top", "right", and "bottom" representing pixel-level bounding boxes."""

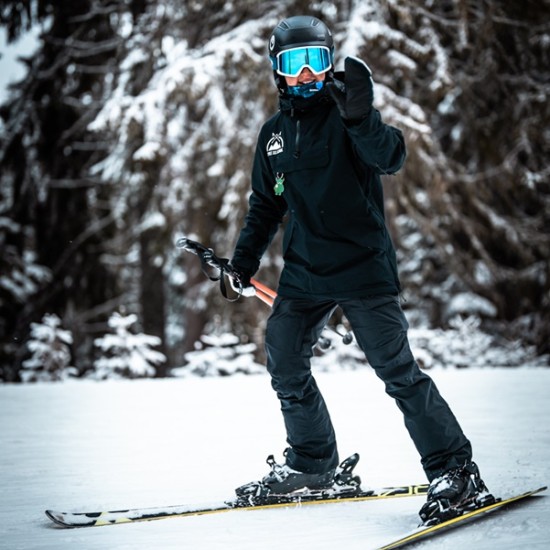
[{"left": 0, "top": 0, "right": 550, "bottom": 381}]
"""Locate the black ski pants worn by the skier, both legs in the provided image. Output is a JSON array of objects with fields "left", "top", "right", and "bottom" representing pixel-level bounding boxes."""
[{"left": 266, "top": 295, "right": 472, "bottom": 481}]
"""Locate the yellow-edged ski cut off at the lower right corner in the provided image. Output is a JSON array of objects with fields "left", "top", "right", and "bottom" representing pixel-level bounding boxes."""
[{"left": 378, "top": 487, "right": 547, "bottom": 550}]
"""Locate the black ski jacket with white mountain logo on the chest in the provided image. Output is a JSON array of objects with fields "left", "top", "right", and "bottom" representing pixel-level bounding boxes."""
[{"left": 232, "top": 85, "right": 405, "bottom": 299}]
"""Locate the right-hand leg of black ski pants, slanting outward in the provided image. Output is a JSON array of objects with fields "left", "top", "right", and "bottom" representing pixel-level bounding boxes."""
[{"left": 340, "top": 295, "right": 472, "bottom": 480}]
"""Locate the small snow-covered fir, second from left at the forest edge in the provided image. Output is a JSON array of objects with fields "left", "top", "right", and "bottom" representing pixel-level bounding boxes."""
[{"left": 89, "top": 312, "right": 166, "bottom": 380}]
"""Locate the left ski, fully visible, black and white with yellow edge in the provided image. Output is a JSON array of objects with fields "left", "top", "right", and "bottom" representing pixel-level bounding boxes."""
[{"left": 46, "top": 485, "right": 428, "bottom": 527}]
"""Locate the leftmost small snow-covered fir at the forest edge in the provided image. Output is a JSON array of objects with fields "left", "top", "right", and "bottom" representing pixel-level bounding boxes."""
[{"left": 20, "top": 314, "right": 77, "bottom": 382}]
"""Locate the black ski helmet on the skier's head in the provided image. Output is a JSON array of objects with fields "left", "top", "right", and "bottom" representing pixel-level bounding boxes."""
[{"left": 268, "top": 15, "right": 334, "bottom": 92}]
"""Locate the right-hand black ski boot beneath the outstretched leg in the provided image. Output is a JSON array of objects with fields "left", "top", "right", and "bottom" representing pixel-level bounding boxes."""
[{"left": 419, "top": 462, "right": 495, "bottom": 525}]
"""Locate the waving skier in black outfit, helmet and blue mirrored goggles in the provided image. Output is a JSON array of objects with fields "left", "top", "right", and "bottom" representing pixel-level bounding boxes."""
[{"left": 231, "top": 11, "right": 487, "bottom": 521}]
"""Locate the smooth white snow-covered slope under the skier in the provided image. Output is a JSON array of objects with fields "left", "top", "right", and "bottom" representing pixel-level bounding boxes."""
[{"left": 0, "top": 367, "right": 550, "bottom": 550}]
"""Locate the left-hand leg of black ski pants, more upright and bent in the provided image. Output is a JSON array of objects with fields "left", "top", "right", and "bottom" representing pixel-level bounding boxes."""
[{"left": 265, "top": 297, "right": 338, "bottom": 473}]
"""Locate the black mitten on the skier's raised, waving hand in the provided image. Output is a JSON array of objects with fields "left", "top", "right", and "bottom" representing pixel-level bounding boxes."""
[{"left": 327, "top": 57, "right": 374, "bottom": 120}]
